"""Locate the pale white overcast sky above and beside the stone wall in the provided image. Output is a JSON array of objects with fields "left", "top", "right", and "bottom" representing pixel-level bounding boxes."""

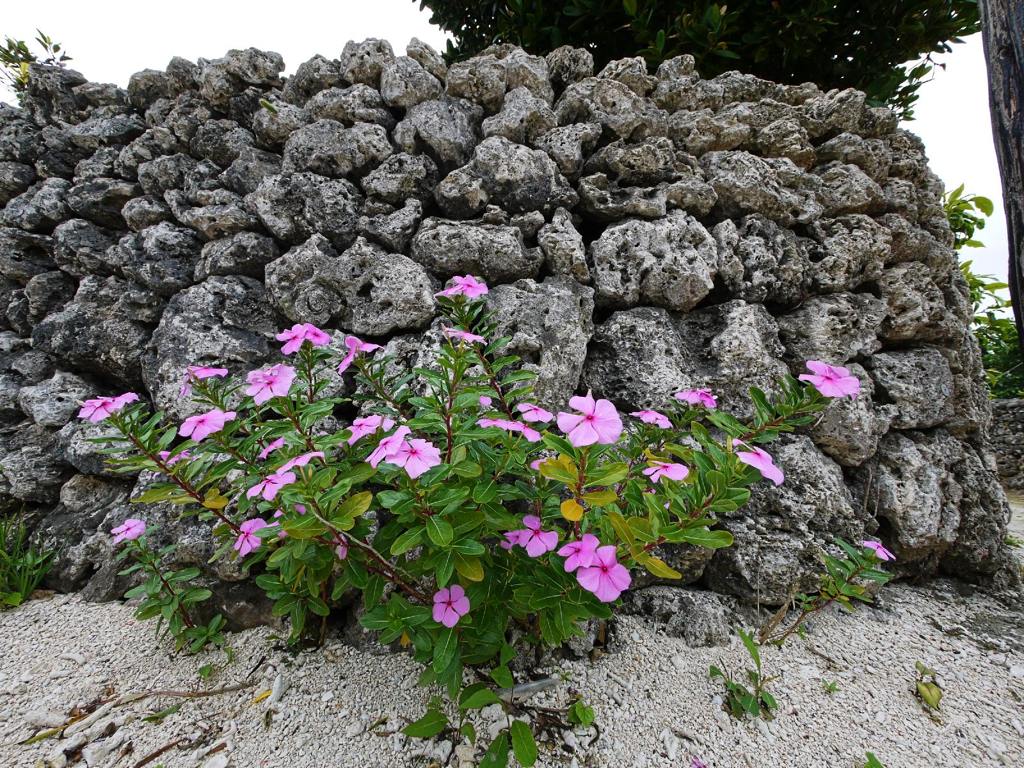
[{"left": 0, "top": 0, "right": 1007, "bottom": 279}]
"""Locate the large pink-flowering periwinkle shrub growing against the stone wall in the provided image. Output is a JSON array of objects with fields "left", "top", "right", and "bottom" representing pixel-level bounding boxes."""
[{"left": 81, "top": 275, "right": 858, "bottom": 762}]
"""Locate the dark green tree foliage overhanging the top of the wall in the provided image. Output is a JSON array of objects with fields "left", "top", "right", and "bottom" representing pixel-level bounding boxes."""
[{"left": 420, "top": 0, "right": 980, "bottom": 117}]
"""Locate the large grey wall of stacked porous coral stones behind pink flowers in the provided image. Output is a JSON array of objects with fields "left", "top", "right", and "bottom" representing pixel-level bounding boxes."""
[{"left": 0, "top": 40, "right": 1008, "bottom": 615}]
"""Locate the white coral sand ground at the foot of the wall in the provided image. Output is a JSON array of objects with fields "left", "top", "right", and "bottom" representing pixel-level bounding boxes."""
[{"left": 0, "top": 583, "right": 1024, "bottom": 768}]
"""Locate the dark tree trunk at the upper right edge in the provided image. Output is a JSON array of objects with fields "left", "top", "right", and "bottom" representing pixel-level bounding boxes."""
[{"left": 981, "top": 0, "right": 1024, "bottom": 349}]
